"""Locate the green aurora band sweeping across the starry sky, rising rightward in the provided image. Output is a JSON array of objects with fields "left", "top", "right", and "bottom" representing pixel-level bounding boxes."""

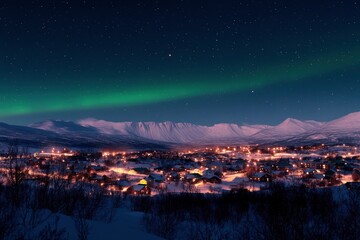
[{"left": 0, "top": 49, "right": 360, "bottom": 117}]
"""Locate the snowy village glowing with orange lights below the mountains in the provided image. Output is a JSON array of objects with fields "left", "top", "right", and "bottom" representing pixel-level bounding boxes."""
[{"left": 0, "top": 144, "right": 360, "bottom": 196}]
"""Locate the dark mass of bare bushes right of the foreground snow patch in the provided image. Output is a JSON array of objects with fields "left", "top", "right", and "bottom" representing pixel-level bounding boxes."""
[{"left": 133, "top": 184, "right": 360, "bottom": 240}]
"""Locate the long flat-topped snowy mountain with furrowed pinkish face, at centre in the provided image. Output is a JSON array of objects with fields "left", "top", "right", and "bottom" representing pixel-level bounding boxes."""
[{"left": 79, "top": 119, "right": 268, "bottom": 144}]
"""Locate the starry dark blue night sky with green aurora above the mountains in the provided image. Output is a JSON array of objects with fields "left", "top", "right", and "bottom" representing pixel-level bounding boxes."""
[{"left": 0, "top": 0, "right": 360, "bottom": 125}]
